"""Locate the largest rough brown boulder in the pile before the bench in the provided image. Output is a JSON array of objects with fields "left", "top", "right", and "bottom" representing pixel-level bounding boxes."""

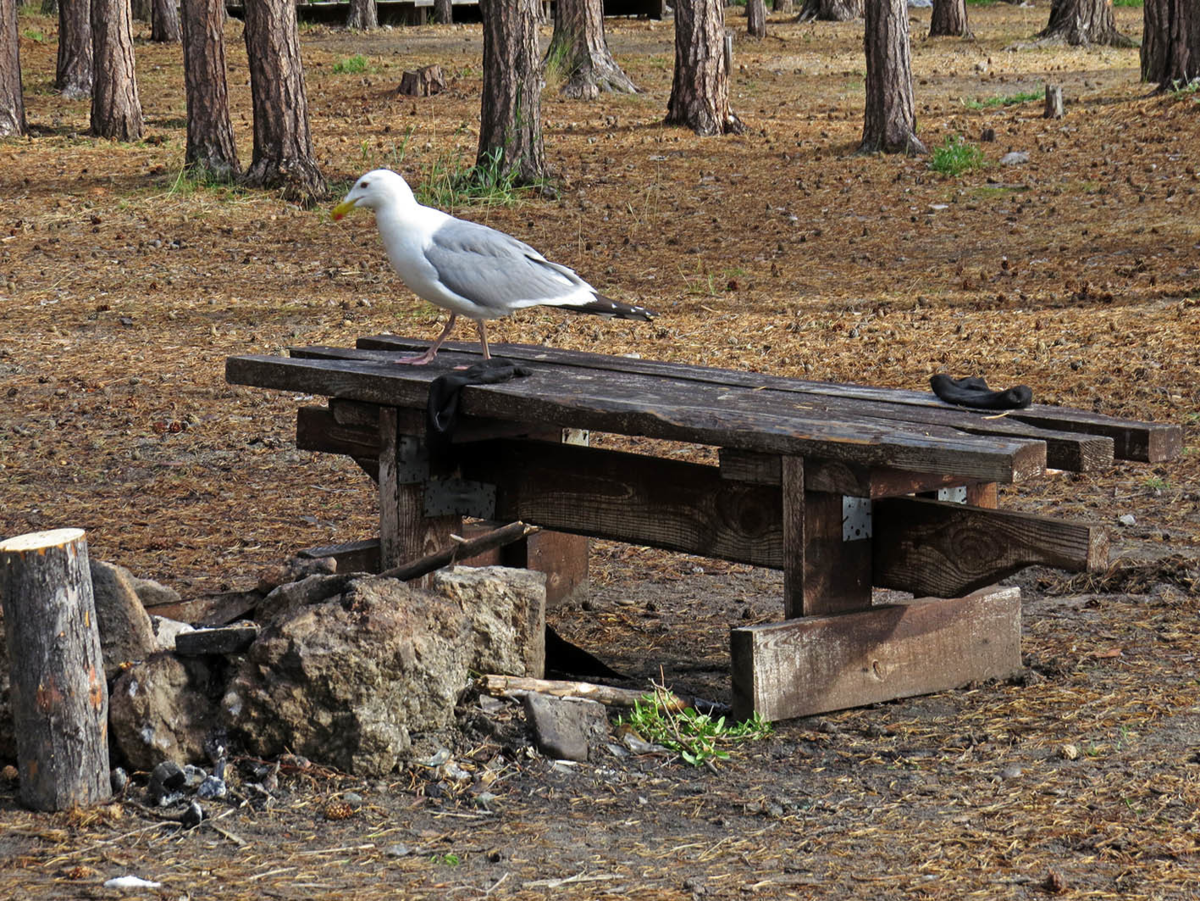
[{"left": 221, "top": 576, "right": 473, "bottom": 776}]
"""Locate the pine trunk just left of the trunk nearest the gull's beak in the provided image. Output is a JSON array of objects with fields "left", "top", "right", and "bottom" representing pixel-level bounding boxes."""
[{"left": 182, "top": 0, "right": 241, "bottom": 181}]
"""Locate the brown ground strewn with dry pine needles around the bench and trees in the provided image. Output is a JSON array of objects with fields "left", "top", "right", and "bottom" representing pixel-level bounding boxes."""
[{"left": 0, "top": 0, "right": 1200, "bottom": 900}]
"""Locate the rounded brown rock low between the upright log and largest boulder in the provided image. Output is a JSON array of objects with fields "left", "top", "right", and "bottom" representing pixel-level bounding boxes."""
[{"left": 108, "top": 653, "right": 220, "bottom": 770}]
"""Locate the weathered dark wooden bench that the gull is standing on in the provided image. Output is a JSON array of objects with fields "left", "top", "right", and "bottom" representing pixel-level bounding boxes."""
[{"left": 227, "top": 336, "right": 1182, "bottom": 720}]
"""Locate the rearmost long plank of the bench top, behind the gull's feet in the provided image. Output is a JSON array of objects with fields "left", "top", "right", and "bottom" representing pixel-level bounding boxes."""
[{"left": 356, "top": 335, "right": 1183, "bottom": 469}]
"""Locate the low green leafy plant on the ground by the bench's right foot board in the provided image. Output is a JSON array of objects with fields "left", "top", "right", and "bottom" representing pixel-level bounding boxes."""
[{"left": 617, "top": 685, "right": 774, "bottom": 767}]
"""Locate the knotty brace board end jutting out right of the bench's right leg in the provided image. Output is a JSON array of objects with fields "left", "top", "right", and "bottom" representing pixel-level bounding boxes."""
[{"left": 871, "top": 498, "right": 1108, "bottom": 597}]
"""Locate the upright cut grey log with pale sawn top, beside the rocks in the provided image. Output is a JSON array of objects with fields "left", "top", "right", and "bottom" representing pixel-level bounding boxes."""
[{"left": 0, "top": 529, "right": 112, "bottom": 810}]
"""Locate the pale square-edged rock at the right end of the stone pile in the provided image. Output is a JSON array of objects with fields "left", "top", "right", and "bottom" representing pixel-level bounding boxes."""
[{"left": 432, "top": 566, "right": 546, "bottom": 679}]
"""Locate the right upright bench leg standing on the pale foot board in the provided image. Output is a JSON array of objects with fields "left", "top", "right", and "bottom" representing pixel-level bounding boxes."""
[{"left": 781, "top": 457, "right": 871, "bottom": 619}]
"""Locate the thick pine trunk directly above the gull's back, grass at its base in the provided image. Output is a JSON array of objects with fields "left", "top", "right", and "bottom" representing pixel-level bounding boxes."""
[{"left": 475, "top": 0, "right": 546, "bottom": 185}]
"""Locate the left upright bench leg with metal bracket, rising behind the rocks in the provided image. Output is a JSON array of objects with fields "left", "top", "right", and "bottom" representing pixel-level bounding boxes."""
[{"left": 379, "top": 407, "right": 462, "bottom": 585}]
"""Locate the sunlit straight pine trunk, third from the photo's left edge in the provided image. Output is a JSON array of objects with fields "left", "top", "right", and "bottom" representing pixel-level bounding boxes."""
[{"left": 91, "top": 0, "right": 145, "bottom": 140}]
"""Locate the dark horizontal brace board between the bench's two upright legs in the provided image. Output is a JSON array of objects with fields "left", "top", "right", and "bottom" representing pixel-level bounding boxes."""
[{"left": 460, "top": 440, "right": 782, "bottom": 569}]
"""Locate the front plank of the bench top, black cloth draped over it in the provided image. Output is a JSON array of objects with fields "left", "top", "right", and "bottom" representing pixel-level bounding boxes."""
[{"left": 227, "top": 352, "right": 1045, "bottom": 482}]
